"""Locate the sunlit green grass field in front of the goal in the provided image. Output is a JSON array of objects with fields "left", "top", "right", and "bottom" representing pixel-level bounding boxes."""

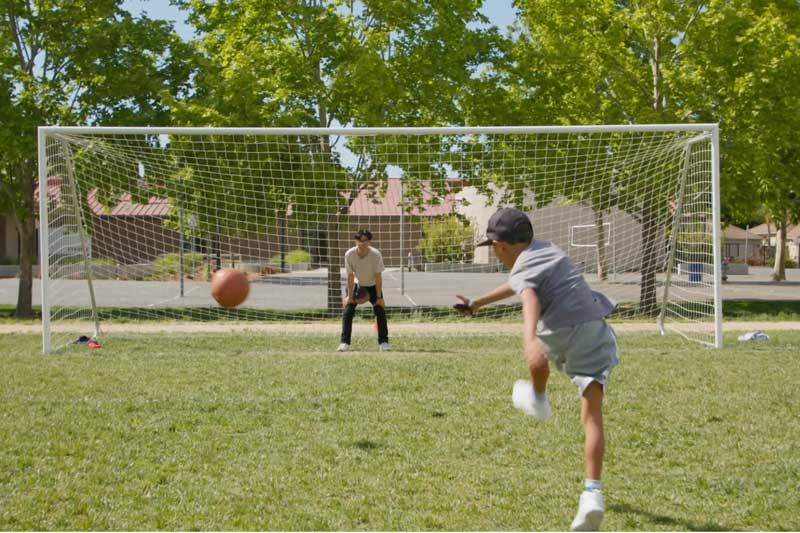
[{"left": 0, "top": 332, "right": 800, "bottom": 530}]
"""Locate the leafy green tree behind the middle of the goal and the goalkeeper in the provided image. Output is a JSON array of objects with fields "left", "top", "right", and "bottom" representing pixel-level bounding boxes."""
[{"left": 174, "top": 0, "right": 504, "bottom": 313}]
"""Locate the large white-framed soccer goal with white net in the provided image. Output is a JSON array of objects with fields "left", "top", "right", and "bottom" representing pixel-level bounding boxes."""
[{"left": 38, "top": 124, "right": 722, "bottom": 352}]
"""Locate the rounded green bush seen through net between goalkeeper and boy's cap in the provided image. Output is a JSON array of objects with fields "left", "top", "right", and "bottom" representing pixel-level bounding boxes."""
[{"left": 417, "top": 216, "right": 475, "bottom": 263}]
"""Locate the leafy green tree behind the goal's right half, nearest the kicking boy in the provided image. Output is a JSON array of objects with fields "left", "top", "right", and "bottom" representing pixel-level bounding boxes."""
[{"left": 498, "top": 0, "right": 706, "bottom": 313}]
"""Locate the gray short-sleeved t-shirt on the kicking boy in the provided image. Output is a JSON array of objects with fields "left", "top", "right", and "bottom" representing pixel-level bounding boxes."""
[{"left": 508, "top": 241, "right": 614, "bottom": 331}]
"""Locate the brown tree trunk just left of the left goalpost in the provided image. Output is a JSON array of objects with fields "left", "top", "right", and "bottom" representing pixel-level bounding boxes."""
[{"left": 14, "top": 161, "right": 36, "bottom": 318}]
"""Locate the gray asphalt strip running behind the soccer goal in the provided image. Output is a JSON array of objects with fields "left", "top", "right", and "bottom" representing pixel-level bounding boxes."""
[{"left": 0, "top": 268, "right": 800, "bottom": 310}]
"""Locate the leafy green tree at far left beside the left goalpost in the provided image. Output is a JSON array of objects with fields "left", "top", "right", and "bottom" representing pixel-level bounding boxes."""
[{"left": 0, "top": 0, "right": 188, "bottom": 316}]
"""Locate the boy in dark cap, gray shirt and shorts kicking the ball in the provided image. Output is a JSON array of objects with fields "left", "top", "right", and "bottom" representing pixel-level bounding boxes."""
[{"left": 455, "top": 208, "right": 619, "bottom": 531}]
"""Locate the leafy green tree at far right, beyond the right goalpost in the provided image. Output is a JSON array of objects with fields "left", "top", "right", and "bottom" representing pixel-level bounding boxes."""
[{"left": 685, "top": 0, "right": 800, "bottom": 281}]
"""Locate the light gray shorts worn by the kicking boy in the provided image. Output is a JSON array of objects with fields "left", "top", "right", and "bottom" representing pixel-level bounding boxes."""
[{"left": 538, "top": 320, "right": 619, "bottom": 396}]
